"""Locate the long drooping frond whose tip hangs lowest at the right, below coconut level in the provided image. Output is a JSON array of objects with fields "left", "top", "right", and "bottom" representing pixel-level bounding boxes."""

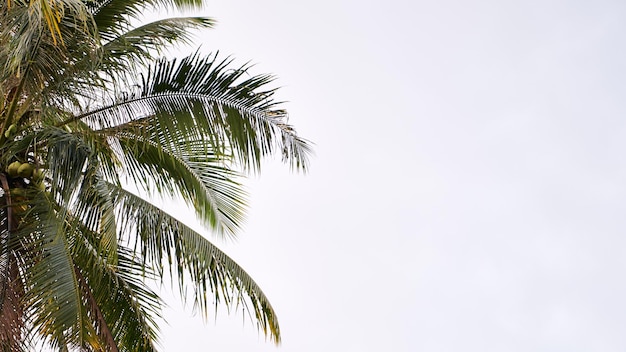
[{"left": 111, "top": 186, "right": 280, "bottom": 342}]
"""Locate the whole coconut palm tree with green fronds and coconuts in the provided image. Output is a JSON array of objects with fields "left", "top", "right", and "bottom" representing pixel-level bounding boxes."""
[{"left": 0, "top": 0, "right": 310, "bottom": 351}]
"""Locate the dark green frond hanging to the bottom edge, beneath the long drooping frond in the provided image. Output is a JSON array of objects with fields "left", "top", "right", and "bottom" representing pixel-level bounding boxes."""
[{"left": 74, "top": 228, "right": 161, "bottom": 351}]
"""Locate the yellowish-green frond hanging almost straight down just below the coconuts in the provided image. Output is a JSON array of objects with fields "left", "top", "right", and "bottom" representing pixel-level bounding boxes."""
[{"left": 16, "top": 192, "right": 83, "bottom": 347}]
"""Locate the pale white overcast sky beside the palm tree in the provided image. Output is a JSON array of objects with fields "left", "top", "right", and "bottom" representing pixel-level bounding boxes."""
[{"left": 146, "top": 0, "right": 626, "bottom": 352}]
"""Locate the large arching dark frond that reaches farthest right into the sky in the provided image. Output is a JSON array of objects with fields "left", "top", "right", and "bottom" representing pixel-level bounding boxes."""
[{"left": 70, "top": 54, "right": 311, "bottom": 170}]
